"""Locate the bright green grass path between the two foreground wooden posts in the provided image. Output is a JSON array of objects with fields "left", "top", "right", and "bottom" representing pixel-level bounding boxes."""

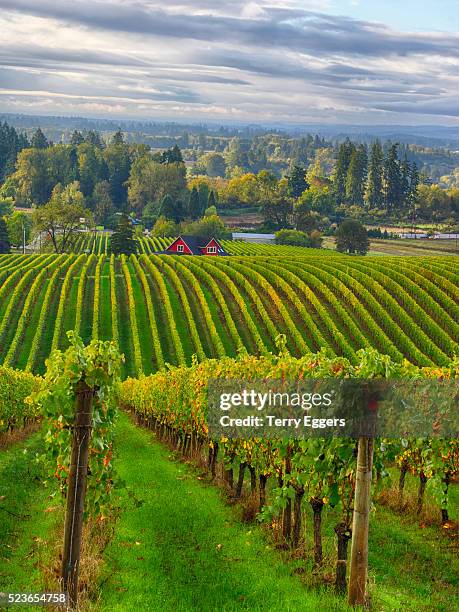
[{"left": 95, "top": 415, "right": 346, "bottom": 612}]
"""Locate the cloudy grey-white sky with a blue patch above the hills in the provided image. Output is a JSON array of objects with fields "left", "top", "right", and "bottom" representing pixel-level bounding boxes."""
[{"left": 0, "top": 0, "right": 459, "bottom": 125}]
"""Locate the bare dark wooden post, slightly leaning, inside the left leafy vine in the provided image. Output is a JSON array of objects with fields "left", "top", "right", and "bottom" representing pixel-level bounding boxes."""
[{"left": 61, "top": 380, "right": 94, "bottom": 608}]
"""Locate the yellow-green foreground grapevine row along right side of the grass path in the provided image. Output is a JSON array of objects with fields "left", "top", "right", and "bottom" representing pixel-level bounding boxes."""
[{"left": 121, "top": 346, "right": 459, "bottom": 591}]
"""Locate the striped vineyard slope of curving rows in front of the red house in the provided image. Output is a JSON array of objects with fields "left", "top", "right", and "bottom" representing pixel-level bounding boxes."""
[{"left": 0, "top": 252, "right": 459, "bottom": 377}]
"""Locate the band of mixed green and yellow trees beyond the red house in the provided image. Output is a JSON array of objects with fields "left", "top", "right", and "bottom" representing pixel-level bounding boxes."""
[{"left": 0, "top": 123, "right": 459, "bottom": 249}]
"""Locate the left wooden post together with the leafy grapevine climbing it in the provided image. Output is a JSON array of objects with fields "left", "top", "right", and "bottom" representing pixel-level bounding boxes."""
[{"left": 30, "top": 331, "right": 123, "bottom": 609}]
